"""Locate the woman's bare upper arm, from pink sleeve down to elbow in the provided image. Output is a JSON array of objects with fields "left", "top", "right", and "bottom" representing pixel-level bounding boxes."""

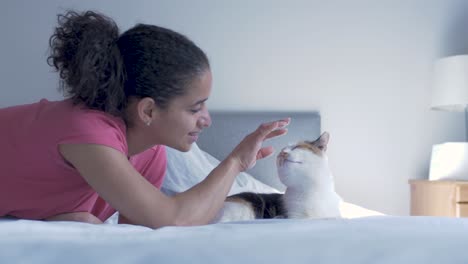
[{"left": 59, "top": 144, "right": 181, "bottom": 228}]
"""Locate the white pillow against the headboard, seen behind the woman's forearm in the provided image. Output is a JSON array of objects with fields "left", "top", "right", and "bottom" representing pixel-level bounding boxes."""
[{"left": 161, "top": 143, "right": 279, "bottom": 195}]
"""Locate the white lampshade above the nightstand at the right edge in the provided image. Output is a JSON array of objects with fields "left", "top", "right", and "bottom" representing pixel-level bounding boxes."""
[{"left": 431, "top": 55, "right": 468, "bottom": 111}]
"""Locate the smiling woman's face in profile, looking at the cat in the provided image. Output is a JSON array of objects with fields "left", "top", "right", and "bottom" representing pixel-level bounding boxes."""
[{"left": 151, "top": 70, "right": 212, "bottom": 151}]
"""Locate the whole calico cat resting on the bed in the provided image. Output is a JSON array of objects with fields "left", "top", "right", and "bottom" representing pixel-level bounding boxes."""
[{"left": 214, "top": 132, "right": 341, "bottom": 222}]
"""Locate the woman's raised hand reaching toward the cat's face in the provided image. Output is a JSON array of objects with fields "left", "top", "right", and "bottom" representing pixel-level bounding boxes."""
[{"left": 228, "top": 118, "right": 291, "bottom": 171}]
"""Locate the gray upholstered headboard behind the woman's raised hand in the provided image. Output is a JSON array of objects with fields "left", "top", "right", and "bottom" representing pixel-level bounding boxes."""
[{"left": 197, "top": 111, "right": 321, "bottom": 190}]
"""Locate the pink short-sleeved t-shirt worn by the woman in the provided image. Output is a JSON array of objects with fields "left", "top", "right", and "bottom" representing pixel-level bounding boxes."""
[{"left": 0, "top": 99, "right": 166, "bottom": 221}]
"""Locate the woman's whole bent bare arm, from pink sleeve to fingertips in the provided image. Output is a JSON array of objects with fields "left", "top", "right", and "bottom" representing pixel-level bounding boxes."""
[{"left": 60, "top": 120, "right": 289, "bottom": 228}]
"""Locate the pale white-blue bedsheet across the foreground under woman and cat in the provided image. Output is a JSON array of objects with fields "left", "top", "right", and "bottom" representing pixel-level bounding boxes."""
[{"left": 0, "top": 216, "right": 468, "bottom": 264}]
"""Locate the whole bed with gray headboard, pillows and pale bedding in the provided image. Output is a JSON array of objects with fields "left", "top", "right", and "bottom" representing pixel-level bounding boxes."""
[{"left": 0, "top": 112, "right": 468, "bottom": 264}]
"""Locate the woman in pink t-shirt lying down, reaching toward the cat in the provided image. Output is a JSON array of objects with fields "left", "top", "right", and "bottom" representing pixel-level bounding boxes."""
[{"left": 0, "top": 11, "right": 289, "bottom": 228}]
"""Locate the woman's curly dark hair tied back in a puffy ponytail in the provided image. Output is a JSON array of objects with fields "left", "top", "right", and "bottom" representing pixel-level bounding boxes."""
[{"left": 47, "top": 11, "right": 210, "bottom": 116}]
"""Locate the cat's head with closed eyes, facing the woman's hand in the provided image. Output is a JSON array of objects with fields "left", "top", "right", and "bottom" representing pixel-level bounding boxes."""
[{"left": 276, "top": 132, "right": 330, "bottom": 187}]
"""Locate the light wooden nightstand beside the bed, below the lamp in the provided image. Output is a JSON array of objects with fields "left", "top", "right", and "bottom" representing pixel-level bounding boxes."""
[{"left": 409, "top": 180, "right": 468, "bottom": 217}]
